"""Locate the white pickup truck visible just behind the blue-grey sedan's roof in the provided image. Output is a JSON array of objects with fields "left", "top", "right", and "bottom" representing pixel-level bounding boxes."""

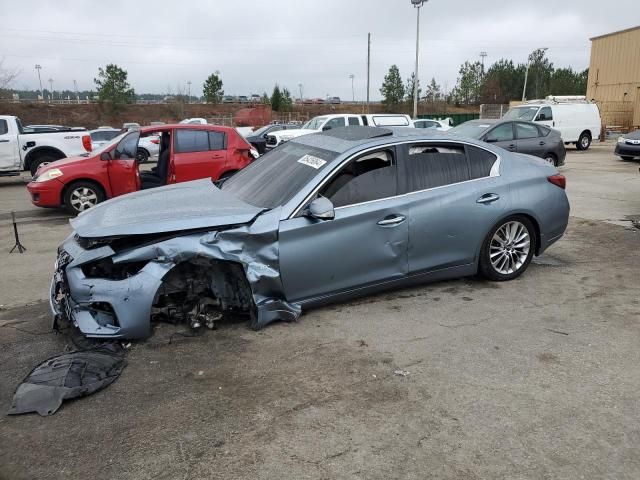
[{"left": 267, "top": 113, "right": 413, "bottom": 150}]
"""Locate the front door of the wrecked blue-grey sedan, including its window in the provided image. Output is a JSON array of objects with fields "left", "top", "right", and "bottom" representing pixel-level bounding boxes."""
[{"left": 279, "top": 148, "right": 408, "bottom": 301}]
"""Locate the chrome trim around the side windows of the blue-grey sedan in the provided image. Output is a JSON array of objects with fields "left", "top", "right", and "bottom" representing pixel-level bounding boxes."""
[{"left": 285, "top": 139, "right": 502, "bottom": 220}]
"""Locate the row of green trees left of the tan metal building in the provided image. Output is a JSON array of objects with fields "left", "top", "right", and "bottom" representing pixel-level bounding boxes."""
[{"left": 380, "top": 49, "right": 589, "bottom": 108}]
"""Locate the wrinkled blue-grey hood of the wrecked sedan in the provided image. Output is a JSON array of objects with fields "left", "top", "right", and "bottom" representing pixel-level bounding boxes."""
[{"left": 71, "top": 179, "right": 264, "bottom": 238}]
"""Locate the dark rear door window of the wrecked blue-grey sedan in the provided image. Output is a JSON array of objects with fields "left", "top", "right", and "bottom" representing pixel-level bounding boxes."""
[{"left": 398, "top": 143, "right": 471, "bottom": 193}]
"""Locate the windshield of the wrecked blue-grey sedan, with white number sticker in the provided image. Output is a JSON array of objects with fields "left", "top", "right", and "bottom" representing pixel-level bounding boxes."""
[{"left": 222, "top": 142, "right": 338, "bottom": 208}]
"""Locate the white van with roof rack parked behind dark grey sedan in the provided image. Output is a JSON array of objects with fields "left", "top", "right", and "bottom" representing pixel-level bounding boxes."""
[{"left": 502, "top": 96, "right": 602, "bottom": 150}]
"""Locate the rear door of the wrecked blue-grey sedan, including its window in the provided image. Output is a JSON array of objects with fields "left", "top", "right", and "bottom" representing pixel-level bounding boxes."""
[{"left": 398, "top": 142, "right": 509, "bottom": 275}]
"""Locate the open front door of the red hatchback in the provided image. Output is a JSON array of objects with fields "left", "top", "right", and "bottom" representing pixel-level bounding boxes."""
[{"left": 107, "top": 131, "right": 140, "bottom": 197}]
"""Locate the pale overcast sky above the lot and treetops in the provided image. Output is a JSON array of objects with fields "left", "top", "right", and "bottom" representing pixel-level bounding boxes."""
[{"left": 0, "top": 0, "right": 638, "bottom": 100}]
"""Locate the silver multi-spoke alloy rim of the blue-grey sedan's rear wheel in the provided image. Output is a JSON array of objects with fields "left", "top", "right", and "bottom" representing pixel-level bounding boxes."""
[{"left": 489, "top": 221, "right": 531, "bottom": 275}]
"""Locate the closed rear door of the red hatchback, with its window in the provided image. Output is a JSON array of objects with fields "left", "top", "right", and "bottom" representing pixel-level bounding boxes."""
[{"left": 169, "top": 129, "right": 227, "bottom": 183}]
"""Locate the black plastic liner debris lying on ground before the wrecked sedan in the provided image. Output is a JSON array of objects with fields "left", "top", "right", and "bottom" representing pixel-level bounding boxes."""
[{"left": 8, "top": 342, "right": 127, "bottom": 416}]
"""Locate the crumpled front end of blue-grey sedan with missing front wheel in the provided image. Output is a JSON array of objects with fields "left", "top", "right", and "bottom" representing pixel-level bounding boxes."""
[{"left": 51, "top": 211, "right": 301, "bottom": 339}]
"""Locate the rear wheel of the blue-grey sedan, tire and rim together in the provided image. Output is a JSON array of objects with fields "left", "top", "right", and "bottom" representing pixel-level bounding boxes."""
[{"left": 478, "top": 215, "right": 536, "bottom": 282}]
